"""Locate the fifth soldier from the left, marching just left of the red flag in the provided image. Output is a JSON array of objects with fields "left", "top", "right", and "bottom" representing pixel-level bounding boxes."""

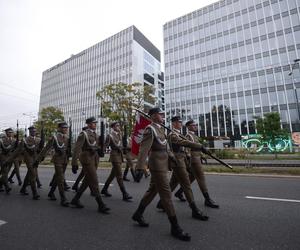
[{"left": 101, "top": 122, "right": 132, "bottom": 201}]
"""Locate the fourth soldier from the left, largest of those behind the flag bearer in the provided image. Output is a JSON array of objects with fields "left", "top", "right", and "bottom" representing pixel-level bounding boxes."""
[{"left": 71, "top": 117, "right": 110, "bottom": 214}]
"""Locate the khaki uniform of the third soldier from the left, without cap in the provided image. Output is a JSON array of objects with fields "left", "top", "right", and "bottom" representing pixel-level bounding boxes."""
[{"left": 38, "top": 132, "right": 69, "bottom": 200}]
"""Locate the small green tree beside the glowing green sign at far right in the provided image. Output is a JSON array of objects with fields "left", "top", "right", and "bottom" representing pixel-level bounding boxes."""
[{"left": 256, "top": 112, "right": 288, "bottom": 158}]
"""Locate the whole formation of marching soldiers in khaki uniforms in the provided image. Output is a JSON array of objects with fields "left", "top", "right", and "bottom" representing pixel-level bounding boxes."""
[{"left": 0, "top": 108, "right": 219, "bottom": 241}]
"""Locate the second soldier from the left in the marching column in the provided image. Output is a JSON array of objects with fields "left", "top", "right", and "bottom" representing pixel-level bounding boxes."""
[{"left": 10, "top": 126, "right": 43, "bottom": 200}]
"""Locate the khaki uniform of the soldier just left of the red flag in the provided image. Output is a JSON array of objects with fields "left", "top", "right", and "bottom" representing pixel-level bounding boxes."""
[{"left": 105, "top": 131, "right": 125, "bottom": 192}]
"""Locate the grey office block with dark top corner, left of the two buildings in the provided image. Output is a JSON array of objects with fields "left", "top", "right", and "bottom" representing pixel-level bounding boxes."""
[{"left": 39, "top": 26, "right": 164, "bottom": 133}]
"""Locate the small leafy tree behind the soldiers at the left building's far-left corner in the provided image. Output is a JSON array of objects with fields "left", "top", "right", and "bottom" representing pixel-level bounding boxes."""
[{"left": 34, "top": 106, "right": 64, "bottom": 138}]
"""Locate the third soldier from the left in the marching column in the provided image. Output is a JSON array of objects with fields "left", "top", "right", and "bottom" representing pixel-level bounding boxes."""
[{"left": 37, "top": 122, "right": 69, "bottom": 207}]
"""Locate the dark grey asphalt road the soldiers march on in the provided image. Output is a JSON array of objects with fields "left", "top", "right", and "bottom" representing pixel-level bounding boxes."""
[{"left": 0, "top": 168, "right": 300, "bottom": 250}]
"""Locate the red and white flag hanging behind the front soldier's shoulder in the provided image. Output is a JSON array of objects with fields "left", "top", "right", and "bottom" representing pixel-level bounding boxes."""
[{"left": 131, "top": 112, "right": 151, "bottom": 155}]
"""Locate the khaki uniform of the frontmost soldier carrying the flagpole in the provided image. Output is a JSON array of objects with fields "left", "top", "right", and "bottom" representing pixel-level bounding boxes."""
[{"left": 136, "top": 123, "right": 175, "bottom": 217}]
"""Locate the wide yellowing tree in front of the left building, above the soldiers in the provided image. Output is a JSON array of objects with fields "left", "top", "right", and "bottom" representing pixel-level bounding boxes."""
[{"left": 96, "top": 82, "right": 156, "bottom": 131}]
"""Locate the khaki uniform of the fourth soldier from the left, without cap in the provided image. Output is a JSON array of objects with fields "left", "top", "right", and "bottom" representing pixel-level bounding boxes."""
[{"left": 72, "top": 129, "right": 100, "bottom": 198}]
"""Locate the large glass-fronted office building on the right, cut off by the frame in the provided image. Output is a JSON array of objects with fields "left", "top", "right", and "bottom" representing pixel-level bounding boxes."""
[{"left": 163, "top": 0, "right": 300, "bottom": 140}]
